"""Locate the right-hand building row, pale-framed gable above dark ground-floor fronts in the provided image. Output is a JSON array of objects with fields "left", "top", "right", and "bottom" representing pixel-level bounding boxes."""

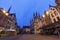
[{"left": 38, "top": 0, "right": 60, "bottom": 35}]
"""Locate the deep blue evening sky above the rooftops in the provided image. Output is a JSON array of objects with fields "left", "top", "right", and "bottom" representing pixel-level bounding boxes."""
[{"left": 0, "top": 0, "right": 55, "bottom": 27}]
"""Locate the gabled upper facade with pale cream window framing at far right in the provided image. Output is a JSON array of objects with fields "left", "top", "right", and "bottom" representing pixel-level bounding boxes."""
[{"left": 49, "top": 0, "right": 60, "bottom": 23}]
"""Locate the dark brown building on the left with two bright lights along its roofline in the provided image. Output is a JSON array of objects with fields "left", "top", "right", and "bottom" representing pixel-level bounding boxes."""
[{"left": 0, "top": 8, "right": 17, "bottom": 35}]
